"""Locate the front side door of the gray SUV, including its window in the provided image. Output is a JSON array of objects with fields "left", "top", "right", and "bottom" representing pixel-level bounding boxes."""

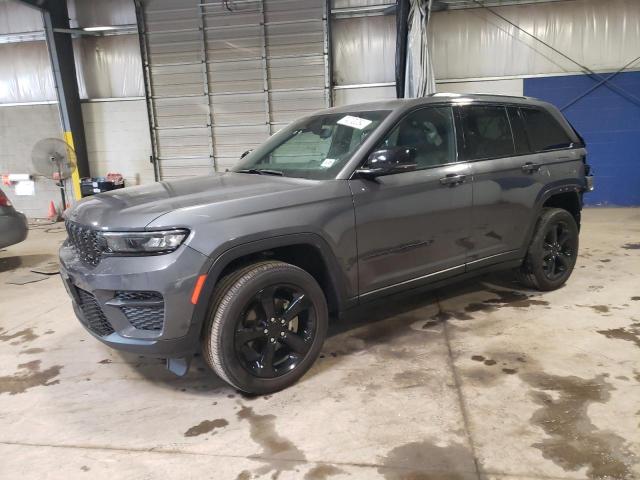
[{"left": 349, "top": 106, "right": 472, "bottom": 296}]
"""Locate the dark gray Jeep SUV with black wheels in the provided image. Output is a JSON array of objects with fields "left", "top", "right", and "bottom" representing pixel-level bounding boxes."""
[{"left": 60, "top": 94, "right": 591, "bottom": 394}]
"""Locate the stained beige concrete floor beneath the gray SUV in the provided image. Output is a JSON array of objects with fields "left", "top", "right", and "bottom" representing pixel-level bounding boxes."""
[{"left": 0, "top": 209, "right": 640, "bottom": 480}]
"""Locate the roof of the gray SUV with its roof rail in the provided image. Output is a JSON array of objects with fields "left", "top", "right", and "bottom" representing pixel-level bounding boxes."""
[{"left": 329, "top": 93, "right": 547, "bottom": 113}]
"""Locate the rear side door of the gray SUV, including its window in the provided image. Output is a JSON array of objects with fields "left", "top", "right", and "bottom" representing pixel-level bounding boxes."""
[{"left": 457, "top": 104, "right": 541, "bottom": 270}]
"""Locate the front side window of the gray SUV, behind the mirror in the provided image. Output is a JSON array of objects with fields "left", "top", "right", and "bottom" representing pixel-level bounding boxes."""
[{"left": 379, "top": 107, "right": 456, "bottom": 169}]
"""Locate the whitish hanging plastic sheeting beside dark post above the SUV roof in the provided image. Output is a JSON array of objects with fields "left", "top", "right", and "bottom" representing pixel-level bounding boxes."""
[{"left": 404, "top": 0, "right": 436, "bottom": 98}]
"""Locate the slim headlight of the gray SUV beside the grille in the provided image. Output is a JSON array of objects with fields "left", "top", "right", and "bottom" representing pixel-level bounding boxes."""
[{"left": 100, "top": 230, "right": 189, "bottom": 255}]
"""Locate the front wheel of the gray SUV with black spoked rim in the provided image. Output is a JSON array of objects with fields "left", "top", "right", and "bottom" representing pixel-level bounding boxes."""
[{"left": 202, "top": 261, "right": 328, "bottom": 395}]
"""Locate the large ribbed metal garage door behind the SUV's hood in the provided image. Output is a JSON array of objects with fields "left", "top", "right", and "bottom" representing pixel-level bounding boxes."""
[{"left": 139, "top": 0, "right": 330, "bottom": 179}]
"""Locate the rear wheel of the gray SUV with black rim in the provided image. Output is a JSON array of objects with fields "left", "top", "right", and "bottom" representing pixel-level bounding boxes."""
[{"left": 516, "top": 208, "right": 579, "bottom": 291}]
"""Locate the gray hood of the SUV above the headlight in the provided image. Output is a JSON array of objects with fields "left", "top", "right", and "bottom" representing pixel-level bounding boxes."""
[{"left": 65, "top": 172, "right": 317, "bottom": 230}]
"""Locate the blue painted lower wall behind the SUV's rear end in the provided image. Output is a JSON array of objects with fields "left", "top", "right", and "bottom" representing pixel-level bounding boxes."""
[{"left": 524, "top": 72, "right": 640, "bottom": 206}]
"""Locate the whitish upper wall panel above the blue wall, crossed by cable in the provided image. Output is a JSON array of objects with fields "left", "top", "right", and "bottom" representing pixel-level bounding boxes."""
[{"left": 430, "top": 0, "right": 640, "bottom": 79}]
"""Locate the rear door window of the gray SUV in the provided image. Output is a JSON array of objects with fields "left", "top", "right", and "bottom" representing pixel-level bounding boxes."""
[{"left": 460, "top": 105, "right": 514, "bottom": 160}]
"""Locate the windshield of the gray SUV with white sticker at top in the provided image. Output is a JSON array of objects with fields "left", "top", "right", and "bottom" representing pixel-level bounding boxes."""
[{"left": 231, "top": 110, "right": 389, "bottom": 180}]
